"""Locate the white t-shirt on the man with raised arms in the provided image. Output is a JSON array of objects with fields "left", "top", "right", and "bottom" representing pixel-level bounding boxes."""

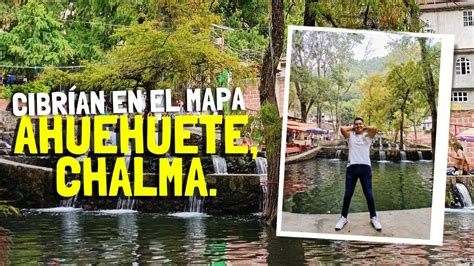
[{"left": 347, "top": 131, "right": 372, "bottom": 166}]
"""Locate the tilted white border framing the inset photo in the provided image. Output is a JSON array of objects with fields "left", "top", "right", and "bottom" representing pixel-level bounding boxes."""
[{"left": 277, "top": 25, "right": 454, "bottom": 245}]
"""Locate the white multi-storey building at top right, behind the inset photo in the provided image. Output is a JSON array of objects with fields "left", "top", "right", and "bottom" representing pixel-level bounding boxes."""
[{"left": 418, "top": 0, "right": 474, "bottom": 110}]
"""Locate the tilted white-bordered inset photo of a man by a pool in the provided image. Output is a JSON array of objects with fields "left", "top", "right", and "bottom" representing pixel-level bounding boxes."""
[{"left": 277, "top": 26, "right": 454, "bottom": 244}]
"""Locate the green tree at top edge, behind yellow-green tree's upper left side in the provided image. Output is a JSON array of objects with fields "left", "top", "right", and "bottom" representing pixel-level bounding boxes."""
[{"left": 60, "top": 0, "right": 157, "bottom": 63}]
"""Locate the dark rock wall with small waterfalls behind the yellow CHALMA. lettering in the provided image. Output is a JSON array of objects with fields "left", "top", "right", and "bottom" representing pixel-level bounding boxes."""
[{"left": 0, "top": 157, "right": 262, "bottom": 214}]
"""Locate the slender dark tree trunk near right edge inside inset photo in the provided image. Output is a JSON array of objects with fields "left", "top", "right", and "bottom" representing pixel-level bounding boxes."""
[{"left": 418, "top": 38, "right": 438, "bottom": 158}]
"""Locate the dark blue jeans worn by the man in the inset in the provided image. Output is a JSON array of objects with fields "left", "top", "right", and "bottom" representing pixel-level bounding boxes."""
[{"left": 341, "top": 164, "right": 377, "bottom": 218}]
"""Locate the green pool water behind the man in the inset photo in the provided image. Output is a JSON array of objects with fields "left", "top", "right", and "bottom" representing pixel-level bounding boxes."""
[{"left": 283, "top": 159, "right": 433, "bottom": 214}]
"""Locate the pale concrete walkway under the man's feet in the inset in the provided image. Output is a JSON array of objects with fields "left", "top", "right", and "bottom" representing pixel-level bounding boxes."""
[{"left": 281, "top": 208, "right": 431, "bottom": 239}]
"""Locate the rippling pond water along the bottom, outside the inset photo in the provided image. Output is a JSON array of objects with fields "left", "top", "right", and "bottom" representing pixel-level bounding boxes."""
[{"left": 0, "top": 211, "right": 474, "bottom": 265}]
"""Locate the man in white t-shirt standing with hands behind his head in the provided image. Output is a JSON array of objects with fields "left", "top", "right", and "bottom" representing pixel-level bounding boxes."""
[{"left": 335, "top": 117, "right": 382, "bottom": 231}]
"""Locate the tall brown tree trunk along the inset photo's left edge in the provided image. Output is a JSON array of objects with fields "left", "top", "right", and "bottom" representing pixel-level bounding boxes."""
[{"left": 258, "top": 0, "right": 285, "bottom": 223}]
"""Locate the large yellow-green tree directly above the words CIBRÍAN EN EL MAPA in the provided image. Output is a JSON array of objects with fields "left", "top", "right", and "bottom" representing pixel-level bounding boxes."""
[{"left": 65, "top": 5, "right": 251, "bottom": 99}]
